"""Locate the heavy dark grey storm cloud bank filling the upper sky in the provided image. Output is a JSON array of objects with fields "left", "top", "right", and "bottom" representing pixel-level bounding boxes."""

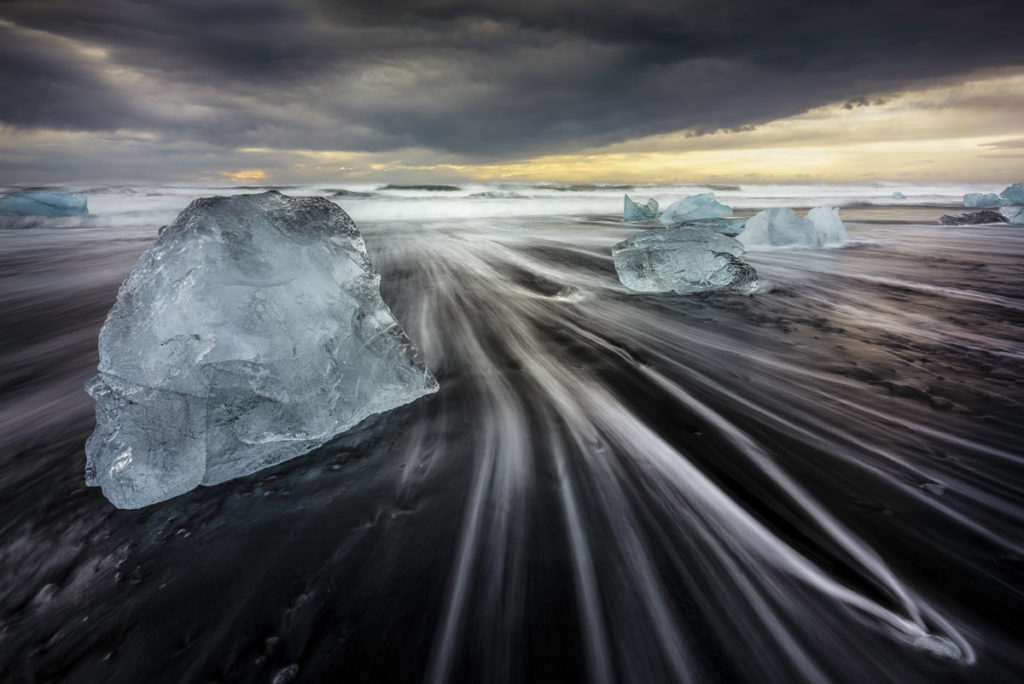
[{"left": 0, "top": 0, "right": 1024, "bottom": 159}]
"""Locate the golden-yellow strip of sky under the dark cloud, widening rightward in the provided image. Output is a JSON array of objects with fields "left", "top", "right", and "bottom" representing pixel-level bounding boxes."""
[{"left": 258, "top": 70, "right": 1024, "bottom": 182}]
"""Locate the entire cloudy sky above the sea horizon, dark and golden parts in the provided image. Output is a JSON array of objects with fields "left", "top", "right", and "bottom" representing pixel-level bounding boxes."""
[{"left": 0, "top": 0, "right": 1024, "bottom": 184}]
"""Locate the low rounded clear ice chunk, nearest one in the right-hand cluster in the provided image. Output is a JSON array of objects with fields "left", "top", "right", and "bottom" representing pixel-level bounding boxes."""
[{"left": 611, "top": 227, "right": 758, "bottom": 294}]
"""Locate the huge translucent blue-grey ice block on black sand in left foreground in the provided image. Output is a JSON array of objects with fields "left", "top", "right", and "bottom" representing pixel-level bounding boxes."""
[{"left": 86, "top": 191, "right": 437, "bottom": 508}]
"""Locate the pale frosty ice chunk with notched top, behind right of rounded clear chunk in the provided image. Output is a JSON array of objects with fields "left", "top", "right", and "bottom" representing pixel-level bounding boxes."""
[{"left": 736, "top": 207, "right": 850, "bottom": 247}]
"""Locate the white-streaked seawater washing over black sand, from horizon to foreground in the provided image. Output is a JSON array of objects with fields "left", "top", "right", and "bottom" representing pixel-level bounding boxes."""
[{"left": 0, "top": 183, "right": 1024, "bottom": 684}]
